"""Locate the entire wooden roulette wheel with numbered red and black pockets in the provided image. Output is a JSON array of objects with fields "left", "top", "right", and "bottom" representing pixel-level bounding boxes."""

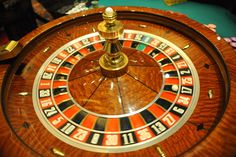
[{"left": 0, "top": 7, "right": 236, "bottom": 157}]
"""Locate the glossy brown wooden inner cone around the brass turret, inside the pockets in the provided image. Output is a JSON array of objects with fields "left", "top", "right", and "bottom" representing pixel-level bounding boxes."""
[{"left": 68, "top": 48, "right": 163, "bottom": 115}]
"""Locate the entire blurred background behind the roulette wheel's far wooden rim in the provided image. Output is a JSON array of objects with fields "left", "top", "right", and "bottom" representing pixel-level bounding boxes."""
[{"left": 0, "top": 0, "right": 236, "bottom": 45}]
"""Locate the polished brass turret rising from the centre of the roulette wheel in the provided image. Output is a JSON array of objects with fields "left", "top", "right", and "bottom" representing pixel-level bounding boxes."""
[{"left": 98, "top": 7, "right": 128, "bottom": 77}]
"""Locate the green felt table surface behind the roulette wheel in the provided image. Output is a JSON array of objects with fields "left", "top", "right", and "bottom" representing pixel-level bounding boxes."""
[{"left": 99, "top": 0, "right": 236, "bottom": 37}]
